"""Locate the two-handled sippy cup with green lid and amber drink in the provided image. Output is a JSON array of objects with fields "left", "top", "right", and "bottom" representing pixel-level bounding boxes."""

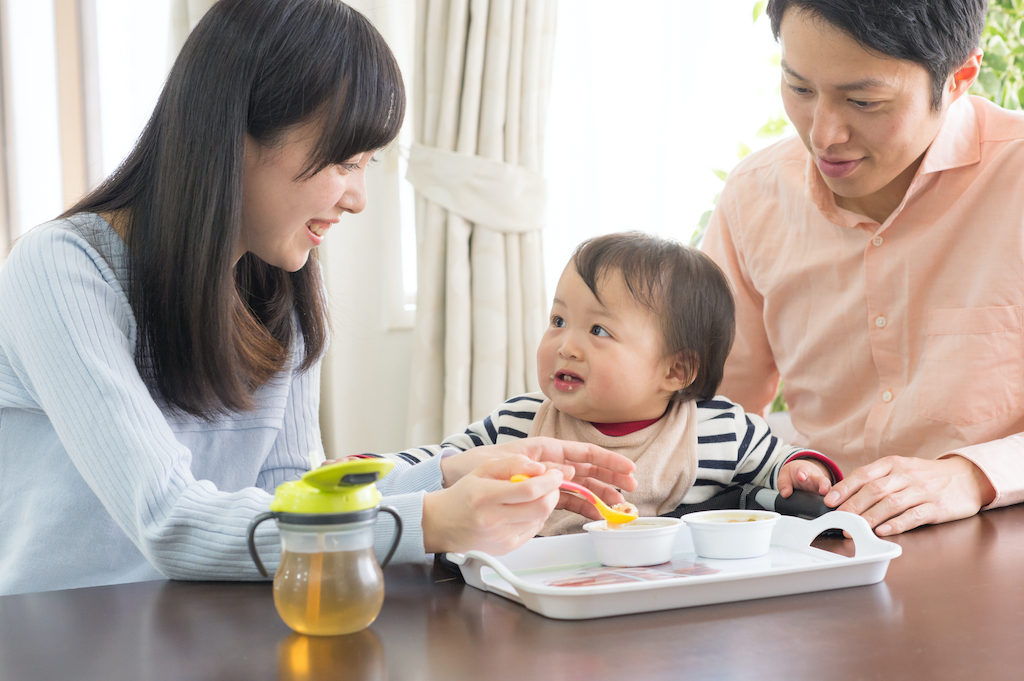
[{"left": 248, "top": 459, "right": 401, "bottom": 636}]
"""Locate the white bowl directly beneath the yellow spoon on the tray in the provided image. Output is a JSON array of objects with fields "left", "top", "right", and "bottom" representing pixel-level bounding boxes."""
[{"left": 583, "top": 518, "right": 680, "bottom": 567}]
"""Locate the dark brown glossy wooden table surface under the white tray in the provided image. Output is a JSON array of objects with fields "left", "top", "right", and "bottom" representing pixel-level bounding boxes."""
[{"left": 0, "top": 506, "right": 1024, "bottom": 681}]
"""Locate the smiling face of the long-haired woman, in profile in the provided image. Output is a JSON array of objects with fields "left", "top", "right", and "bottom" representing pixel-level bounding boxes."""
[{"left": 236, "top": 124, "right": 374, "bottom": 271}]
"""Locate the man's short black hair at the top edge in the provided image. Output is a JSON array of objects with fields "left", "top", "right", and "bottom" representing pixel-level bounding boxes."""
[{"left": 767, "top": 0, "right": 988, "bottom": 111}]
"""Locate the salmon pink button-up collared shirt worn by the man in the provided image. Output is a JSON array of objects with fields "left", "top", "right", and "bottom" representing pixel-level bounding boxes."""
[{"left": 703, "top": 96, "right": 1024, "bottom": 507}]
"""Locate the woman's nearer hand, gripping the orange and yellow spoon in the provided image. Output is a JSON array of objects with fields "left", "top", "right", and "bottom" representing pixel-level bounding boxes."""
[{"left": 423, "top": 455, "right": 564, "bottom": 556}]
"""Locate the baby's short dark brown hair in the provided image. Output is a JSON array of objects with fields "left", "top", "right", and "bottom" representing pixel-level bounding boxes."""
[{"left": 571, "top": 231, "right": 736, "bottom": 400}]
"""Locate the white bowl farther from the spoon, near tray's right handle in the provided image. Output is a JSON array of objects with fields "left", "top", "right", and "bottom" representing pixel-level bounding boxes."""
[{"left": 681, "top": 509, "right": 779, "bottom": 559}]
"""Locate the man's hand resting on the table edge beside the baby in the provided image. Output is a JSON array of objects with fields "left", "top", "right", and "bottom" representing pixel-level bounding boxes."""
[{"left": 824, "top": 456, "right": 995, "bottom": 537}]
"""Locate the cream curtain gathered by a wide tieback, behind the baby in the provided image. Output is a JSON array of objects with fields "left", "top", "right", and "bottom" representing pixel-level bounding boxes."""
[{"left": 407, "top": 0, "right": 557, "bottom": 443}]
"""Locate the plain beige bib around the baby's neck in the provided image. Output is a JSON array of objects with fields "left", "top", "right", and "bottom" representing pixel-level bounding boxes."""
[{"left": 529, "top": 399, "right": 697, "bottom": 537}]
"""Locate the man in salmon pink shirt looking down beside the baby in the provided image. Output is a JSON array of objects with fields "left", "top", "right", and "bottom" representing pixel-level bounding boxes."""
[{"left": 705, "top": 0, "right": 1024, "bottom": 536}]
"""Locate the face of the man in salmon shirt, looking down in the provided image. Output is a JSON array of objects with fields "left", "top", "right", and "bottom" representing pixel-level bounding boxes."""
[{"left": 779, "top": 9, "right": 949, "bottom": 222}]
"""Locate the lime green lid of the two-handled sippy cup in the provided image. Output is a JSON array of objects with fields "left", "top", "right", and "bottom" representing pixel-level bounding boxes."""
[{"left": 270, "top": 458, "right": 394, "bottom": 513}]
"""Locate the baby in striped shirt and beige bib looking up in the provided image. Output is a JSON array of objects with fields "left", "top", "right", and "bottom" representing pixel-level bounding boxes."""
[{"left": 378, "top": 232, "right": 842, "bottom": 536}]
